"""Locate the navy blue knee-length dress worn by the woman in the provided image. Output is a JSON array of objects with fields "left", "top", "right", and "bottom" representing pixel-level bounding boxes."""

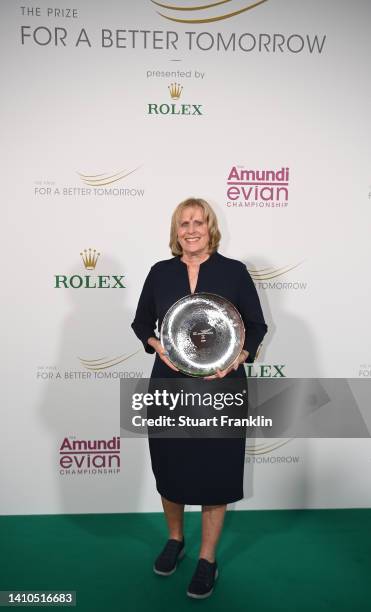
[{"left": 132, "top": 252, "right": 267, "bottom": 505}]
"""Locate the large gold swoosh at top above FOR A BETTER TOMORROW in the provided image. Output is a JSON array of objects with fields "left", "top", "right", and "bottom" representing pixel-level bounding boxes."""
[{"left": 151, "top": 0, "right": 267, "bottom": 24}]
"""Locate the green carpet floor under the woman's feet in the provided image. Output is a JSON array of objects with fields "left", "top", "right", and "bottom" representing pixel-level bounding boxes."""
[{"left": 0, "top": 509, "right": 371, "bottom": 612}]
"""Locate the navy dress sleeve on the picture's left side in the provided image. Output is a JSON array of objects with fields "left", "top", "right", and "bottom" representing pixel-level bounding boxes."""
[{"left": 131, "top": 266, "right": 157, "bottom": 353}]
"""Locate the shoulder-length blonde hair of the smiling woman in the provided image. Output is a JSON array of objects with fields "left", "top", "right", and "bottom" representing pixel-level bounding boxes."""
[{"left": 169, "top": 198, "right": 221, "bottom": 255}]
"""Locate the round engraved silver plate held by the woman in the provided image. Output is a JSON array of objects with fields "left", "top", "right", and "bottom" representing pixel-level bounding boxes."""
[{"left": 161, "top": 293, "right": 245, "bottom": 376}]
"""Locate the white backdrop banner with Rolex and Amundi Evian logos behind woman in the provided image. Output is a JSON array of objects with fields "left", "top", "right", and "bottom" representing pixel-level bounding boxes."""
[{"left": 0, "top": 0, "right": 371, "bottom": 514}]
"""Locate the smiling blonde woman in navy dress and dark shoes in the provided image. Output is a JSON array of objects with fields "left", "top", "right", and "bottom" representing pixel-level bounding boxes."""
[{"left": 132, "top": 198, "right": 267, "bottom": 598}]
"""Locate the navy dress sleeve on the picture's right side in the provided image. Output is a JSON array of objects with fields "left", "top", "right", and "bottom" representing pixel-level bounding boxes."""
[{"left": 236, "top": 265, "right": 268, "bottom": 363}]
